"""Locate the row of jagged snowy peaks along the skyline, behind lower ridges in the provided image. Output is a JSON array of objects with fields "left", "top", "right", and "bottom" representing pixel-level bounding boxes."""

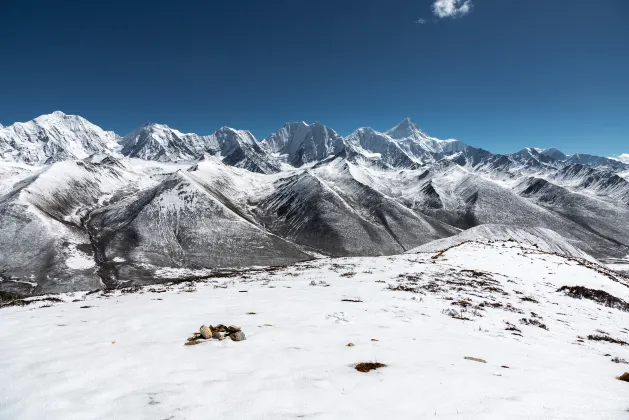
[{"left": 0, "top": 111, "right": 629, "bottom": 173}]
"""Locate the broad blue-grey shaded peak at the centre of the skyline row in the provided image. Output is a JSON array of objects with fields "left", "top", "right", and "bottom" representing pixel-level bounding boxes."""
[{"left": 262, "top": 122, "right": 344, "bottom": 167}]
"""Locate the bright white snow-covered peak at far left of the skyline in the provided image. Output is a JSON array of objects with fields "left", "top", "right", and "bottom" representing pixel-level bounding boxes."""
[{"left": 0, "top": 111, "right": 118, "bottom": 165}]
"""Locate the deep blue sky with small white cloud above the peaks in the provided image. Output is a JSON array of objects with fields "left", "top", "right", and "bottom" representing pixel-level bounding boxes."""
[{"left": 0, "top": 0, "right": 629, "bottom": 156}]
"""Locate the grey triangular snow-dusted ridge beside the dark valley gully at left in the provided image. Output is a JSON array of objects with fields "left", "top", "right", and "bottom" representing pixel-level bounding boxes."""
[{"left": 87, "top": 171, "right": 311, "bottom": 287}]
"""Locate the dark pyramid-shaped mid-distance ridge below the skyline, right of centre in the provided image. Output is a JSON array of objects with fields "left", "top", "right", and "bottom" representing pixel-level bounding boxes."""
[{"left": 250, "top": 158, "right": 457, "bottom": 256}]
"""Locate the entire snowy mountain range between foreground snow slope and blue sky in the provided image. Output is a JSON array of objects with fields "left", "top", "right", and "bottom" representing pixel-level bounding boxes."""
[{"left": 0, "top": 112, "right": 629, "bottom": 295}]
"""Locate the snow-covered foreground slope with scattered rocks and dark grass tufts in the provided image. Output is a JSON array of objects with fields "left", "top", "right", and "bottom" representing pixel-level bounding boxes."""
[{"left": 0, "top": 242, "right": 629, "bottom": 420}]
